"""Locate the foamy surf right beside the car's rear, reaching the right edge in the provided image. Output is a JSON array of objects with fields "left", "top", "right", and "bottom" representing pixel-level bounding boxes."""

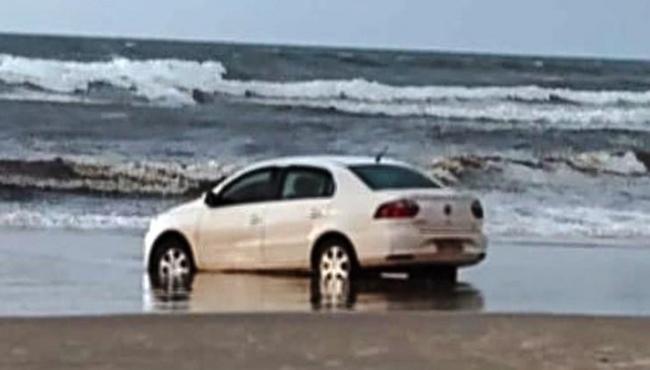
[{"left": 430, "top": 151, "right": 650, "bottom": 240}]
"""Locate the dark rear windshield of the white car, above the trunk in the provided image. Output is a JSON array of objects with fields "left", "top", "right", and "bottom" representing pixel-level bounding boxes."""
[{"left": 350, "top": 164, "right": 440, "bottom": 190}]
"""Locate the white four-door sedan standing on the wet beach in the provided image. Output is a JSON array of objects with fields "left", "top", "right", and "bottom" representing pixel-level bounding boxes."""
[{"left": 144, "top": 156, "right": 487, "bottom": 281}]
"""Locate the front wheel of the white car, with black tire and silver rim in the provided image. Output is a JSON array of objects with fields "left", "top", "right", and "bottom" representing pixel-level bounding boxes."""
[{"left": 148, "top": 237, "right": 196, "bottom": 290}]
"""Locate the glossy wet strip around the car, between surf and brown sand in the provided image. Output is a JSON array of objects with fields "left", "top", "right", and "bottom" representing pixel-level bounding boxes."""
[{"left": 0, "top": 230, "right": 650, "bottom": 316}]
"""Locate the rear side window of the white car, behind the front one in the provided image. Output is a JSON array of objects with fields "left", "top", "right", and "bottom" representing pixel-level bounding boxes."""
[{"left": 282, "top": 168, "right": 334, "bottom": 199}]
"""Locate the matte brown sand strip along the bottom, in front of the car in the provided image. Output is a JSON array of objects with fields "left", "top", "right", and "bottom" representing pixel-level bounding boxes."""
[{"left": 0, "top": 312, "right": 650, "bottom": 370}]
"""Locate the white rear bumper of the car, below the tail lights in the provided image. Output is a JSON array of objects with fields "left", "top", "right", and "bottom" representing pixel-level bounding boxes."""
[{"left": 358, "top": 225, "right": 487, "bottom": 268}]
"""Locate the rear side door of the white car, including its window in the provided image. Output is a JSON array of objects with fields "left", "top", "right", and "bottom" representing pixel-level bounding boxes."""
[{"left": 263, "top": 166, "right": 335, "bottom": 268}]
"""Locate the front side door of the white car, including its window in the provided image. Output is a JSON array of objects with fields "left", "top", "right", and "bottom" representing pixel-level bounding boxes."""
[{"left": 198, "top": 167, "right": 279, "bottom": 269}]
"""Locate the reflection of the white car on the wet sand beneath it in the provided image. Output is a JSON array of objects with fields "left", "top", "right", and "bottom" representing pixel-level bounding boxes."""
[{"left": 143, "top": 273, "right": 484, "bottom": 312}]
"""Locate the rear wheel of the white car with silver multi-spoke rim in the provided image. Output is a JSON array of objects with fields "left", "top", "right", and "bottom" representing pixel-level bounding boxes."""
[{"left": 312, "top": 238, "right": 359, "bottom": 279}]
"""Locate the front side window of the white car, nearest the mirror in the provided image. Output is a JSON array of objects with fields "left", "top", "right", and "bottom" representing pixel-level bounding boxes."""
[{"left": 220, "top": 168, "right": 278, "bottom": 204}]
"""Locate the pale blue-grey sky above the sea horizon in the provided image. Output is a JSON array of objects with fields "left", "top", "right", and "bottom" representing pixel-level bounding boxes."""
[{"left": 0, "top": 0, "right": 650, "bottom": 59}]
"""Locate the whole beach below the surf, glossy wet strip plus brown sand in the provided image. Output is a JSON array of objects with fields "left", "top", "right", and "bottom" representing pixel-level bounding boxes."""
[{"left": 0, "top": 230, "right": 650, "bottom": 370}]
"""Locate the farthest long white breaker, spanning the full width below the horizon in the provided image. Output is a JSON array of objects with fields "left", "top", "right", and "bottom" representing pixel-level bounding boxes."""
[{"left": 0, "top": 54, "right": 650, "bottom": 124}]
